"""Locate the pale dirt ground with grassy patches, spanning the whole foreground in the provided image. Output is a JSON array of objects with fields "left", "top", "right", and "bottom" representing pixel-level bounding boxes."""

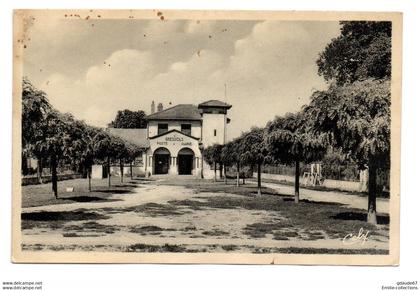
[{"left": 18, "top": 180, "right": 389, "bottom": 254}]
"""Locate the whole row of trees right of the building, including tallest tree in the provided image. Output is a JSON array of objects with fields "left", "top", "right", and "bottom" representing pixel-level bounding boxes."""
[{"left": 204, "top": 21, "right": 391, "bottom": 224}]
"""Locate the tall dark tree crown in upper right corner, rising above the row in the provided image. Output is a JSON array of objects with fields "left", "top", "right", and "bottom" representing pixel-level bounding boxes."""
[{"left": 317, "top": 21, "right": 392, "bottom": 85}]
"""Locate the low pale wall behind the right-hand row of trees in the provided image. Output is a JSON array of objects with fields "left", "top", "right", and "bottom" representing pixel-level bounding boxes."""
[{"left": 253, "top": 172, "right": 362, "bottom": 191}]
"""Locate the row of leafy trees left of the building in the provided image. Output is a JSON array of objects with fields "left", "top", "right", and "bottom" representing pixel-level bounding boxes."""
[{"left": 22, "top": 78, "right": 142, "bottom": 198}]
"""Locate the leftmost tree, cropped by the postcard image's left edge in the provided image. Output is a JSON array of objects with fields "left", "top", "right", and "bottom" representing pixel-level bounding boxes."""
[{"left": 22, "top": 78, "right": 52, "bottom": 183}]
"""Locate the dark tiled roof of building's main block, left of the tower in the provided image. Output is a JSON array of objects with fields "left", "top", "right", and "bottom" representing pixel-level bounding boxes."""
[{"left": 146, "top": 104, "right": 201, "bottom": 120}]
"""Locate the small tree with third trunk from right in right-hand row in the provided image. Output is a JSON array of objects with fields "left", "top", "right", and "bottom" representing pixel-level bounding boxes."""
[{"left": 240, "top": 128, "right": 268, "bottom": 195}]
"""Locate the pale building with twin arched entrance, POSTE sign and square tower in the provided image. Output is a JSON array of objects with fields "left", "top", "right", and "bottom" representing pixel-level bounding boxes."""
[{"left": 107, "top": 100, "right": 231, "bottom": 178}]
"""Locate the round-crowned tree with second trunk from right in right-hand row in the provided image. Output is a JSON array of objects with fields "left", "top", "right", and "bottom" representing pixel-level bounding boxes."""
[{"left": 265, "top": 111, "right": 328, "bottom": 203}]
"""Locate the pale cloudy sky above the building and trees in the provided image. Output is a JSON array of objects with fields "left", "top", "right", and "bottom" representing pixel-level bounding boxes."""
[{"left": 23, "top": 17, "right": 339, "bottom": 139}]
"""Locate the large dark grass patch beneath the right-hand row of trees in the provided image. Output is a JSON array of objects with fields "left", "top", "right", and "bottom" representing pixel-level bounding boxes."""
[{"left": 169, "top": 183, "right": 389, "bottom": 240}]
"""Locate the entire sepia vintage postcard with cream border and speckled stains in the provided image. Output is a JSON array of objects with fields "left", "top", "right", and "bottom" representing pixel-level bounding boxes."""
[{"left": 12, "top": 10, "right": 402, "bottom": 265}]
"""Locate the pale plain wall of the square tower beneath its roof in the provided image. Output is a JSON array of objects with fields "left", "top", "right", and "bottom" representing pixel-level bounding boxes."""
[{"left": 203, "top": 114, "right": 226, "bottom": 147}]
